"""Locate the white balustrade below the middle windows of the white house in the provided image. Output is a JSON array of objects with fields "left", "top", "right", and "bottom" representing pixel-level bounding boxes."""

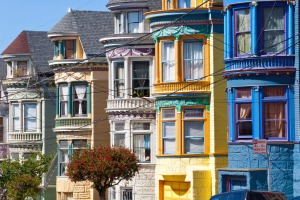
[{"left": 106, "top": 98, "right": 155, "bottom": 111}]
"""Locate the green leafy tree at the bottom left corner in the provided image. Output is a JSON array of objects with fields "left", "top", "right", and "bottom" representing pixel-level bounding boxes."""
[{"left": 0, "top": 153, "right": 52, "bottom": 200}]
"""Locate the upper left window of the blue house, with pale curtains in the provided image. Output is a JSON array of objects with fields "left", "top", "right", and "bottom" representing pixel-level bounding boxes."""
[{"left": 235, "top": 9, "right": 251, "bottom": 55}]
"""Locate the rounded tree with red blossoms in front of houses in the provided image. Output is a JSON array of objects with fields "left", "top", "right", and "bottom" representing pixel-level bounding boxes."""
[{"left": 67, "top": 146, "right": 140, "bottom": 200}]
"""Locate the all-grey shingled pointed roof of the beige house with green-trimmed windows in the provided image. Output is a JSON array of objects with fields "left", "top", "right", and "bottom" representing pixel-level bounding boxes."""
[{"left": 48, "top": 10, "right": 114, "bottom": 57}]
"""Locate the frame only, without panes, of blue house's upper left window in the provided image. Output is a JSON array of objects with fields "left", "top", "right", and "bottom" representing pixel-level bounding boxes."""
[{"left": 234, "top": 7, "right": 251, "bottom": 57}]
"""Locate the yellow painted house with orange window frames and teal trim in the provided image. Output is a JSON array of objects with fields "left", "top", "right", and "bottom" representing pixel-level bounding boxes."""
[{"left": 145, "top": 0, "right": 227, "bottom": 200}]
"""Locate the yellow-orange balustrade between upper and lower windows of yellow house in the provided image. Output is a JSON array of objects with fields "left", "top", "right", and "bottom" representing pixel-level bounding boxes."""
[{"left": 154, "top": 81, "right": 210, "bottom": 94}]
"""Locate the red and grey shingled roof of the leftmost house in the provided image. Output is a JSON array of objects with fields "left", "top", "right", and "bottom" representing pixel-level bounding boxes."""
[{"left": 1, "top": 31, "right": 53, "bottom": 74}]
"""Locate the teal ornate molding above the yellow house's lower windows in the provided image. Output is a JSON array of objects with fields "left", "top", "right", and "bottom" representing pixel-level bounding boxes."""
[{"left": 156, "top": 97, "right": 210, "bottom": 113}]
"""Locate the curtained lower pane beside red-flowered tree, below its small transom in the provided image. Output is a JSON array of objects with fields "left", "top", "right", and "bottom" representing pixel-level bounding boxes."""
[{"left": 133, "top": 134, "right": 151, "bottom": 162}]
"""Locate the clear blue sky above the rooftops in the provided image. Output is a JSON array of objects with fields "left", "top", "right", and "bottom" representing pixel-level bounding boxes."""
[{"left": 0, "top": 0, "right": 109, "bottom": 54}]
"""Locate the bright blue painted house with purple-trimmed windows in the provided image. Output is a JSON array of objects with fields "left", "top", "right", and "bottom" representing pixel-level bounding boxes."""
[{"left": 219, "top": 0, "right": 300, "bottom": 199}]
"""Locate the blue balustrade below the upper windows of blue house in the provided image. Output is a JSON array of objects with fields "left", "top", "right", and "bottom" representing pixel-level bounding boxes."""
[{"left": 225, "top": 56, "right": 295, "bottom": 71}]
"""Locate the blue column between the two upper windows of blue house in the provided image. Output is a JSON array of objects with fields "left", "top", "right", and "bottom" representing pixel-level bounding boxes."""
[{"left": 250, "top": 2, "right": 258, "bottom": 56}]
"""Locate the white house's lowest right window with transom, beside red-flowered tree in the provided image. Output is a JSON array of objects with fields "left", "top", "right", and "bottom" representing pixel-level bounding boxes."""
[{"left": 133, "top": 122, "right": 151, "bottom": 162}]
